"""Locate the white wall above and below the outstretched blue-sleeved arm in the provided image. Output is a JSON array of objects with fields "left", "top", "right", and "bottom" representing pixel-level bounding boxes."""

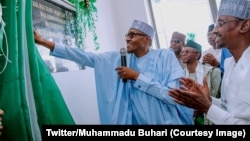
[{"left": 52, "top": 0, "right": 151, "bottom": 124}]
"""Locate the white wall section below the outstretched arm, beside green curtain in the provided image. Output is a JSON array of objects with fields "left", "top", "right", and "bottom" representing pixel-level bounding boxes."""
[{"left": 53, "top": 68, "right": 100, "bottom": 124}]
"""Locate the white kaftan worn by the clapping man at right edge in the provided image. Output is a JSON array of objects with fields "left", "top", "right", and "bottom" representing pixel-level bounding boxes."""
[{"left": 207, "top": 46, "right": 250, "bottom": 124}]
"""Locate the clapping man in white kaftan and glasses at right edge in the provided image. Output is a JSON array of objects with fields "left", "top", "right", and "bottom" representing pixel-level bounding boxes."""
[{"left": 169, "top": 0, "right": 250, "bottom": 125}]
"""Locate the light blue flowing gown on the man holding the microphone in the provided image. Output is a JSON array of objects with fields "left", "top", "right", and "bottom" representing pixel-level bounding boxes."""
[{"left": 50, "top": 45, "right": 193, "bottom": 125}]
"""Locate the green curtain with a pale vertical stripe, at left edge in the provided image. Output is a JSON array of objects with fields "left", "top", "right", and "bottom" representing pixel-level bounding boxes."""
[{"left": 0, "top": 0, "right": 75, "bottom": 141}]
